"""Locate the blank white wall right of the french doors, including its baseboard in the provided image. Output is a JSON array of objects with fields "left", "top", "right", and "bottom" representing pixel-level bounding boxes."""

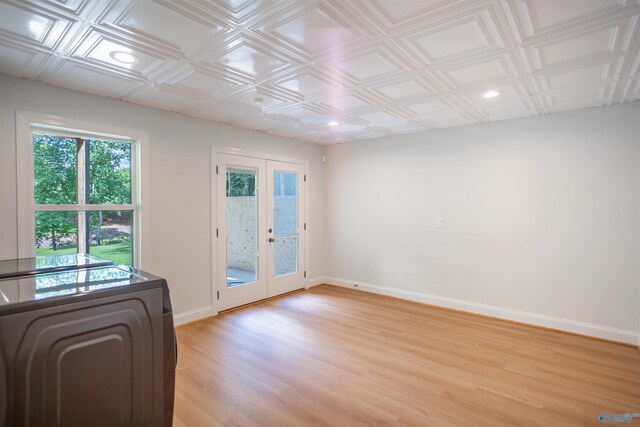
[{"left": 325, "top": 102, "right": 640, "bottom": 344}]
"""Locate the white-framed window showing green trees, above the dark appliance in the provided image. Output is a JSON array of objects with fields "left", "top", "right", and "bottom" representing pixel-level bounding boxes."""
[{"left": 18, "top": 113, "right": 149, "bottom": 267}]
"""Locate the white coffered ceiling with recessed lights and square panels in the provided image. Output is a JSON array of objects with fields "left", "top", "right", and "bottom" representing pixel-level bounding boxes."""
[{"left": 0, "top": 0, "right": 640, "bottom": 144}]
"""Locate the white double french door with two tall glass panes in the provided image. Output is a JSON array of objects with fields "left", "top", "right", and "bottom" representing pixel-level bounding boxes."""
[{"left": 214, "top": 154, "right": 305, "bottom": 310}]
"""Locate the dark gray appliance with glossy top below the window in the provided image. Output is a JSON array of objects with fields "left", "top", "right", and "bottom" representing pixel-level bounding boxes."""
[{"left": 0, "top": 259, "right": 176, "bottom": 427}]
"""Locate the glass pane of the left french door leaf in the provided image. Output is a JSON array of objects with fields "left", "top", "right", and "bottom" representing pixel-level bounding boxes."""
[{"left": 226, "top": 165, "right": 258, "bottom": 287}]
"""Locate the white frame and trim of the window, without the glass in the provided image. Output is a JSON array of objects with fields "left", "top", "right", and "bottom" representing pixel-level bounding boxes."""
[{"left": 16, "top": 111, "right": 149, "bottom": 268}]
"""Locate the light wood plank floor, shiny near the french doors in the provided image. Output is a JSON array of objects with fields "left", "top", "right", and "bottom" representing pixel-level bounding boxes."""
[{"left": 174, "top": 285, "right": 640, "bottom": 427}]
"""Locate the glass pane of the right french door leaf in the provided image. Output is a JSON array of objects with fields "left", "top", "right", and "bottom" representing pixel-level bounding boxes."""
[{"left": 273, "top": 171, "right": 298, "bottom": 277}]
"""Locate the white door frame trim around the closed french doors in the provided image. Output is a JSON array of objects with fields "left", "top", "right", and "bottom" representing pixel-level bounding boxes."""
[{"left": 209, "top": 145, "right": 310, "bottom": 315}]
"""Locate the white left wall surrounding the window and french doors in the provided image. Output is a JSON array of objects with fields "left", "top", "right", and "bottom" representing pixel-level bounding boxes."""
[{"left": 0, "top": 75, "right": 324, "bottom": 319}]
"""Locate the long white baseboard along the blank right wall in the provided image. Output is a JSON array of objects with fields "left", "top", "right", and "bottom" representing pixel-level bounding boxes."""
[{"left": 322, "top": 277, "right": 640, "bottom": 346}]
